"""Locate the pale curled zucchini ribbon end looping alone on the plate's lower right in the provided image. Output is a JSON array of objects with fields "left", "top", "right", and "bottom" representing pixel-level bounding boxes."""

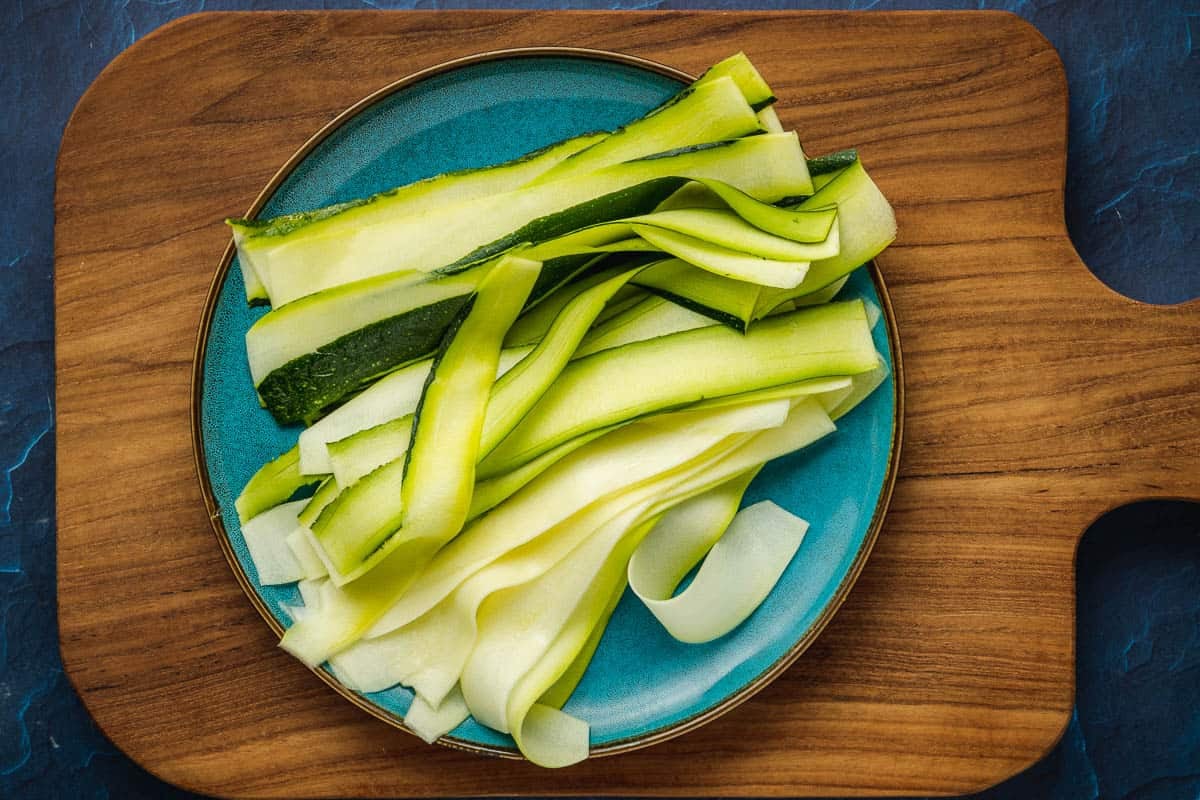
[{"left": 629, "top": 496, "right": 809, "bottom": 644}]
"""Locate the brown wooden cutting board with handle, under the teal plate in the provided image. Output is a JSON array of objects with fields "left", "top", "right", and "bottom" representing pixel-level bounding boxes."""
[{"left": 55, "top": 12, "right": 1200, "bottom": 796}]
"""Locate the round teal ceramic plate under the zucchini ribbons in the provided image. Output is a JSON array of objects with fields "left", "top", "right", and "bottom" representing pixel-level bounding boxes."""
[{"left": 193, "top": 49, "right": 901, "bottom": 754}]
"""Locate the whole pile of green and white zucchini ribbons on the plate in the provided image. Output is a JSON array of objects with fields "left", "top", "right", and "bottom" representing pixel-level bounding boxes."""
[{"left": 229, "top": 54, "right": 895, "bottom": 766}]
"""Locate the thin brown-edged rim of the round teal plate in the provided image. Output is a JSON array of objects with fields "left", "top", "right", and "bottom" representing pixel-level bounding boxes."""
[{"left": 188, "top": 46, "right": 905, "bottom": 760}]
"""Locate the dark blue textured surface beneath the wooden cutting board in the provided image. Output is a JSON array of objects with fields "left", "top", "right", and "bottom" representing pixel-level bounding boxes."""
[{"left": 0, "top": 0, "right": 1200, "bottom": 800}]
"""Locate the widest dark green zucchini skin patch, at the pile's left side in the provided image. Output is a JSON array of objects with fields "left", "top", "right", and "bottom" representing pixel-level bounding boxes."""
[{"left": 258, "top": 293, "right": 472, "bottom": 425}]
